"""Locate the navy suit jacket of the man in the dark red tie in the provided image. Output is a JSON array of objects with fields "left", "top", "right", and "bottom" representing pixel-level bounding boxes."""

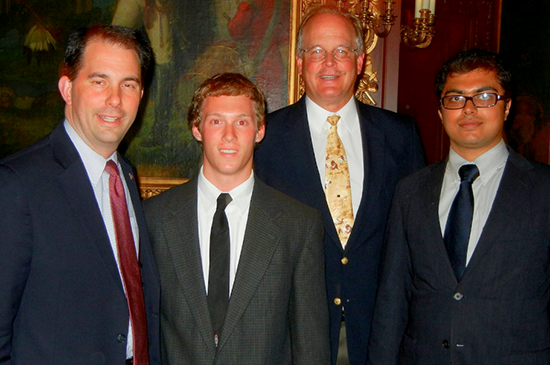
[{"left": 0, "top": 123, "right": 160, "bottom": 365}]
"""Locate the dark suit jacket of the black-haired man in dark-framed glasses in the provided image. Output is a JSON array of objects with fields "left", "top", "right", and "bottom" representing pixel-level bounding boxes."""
[{"left": 369, "top": 152, "right": 550, "bottom": 365}]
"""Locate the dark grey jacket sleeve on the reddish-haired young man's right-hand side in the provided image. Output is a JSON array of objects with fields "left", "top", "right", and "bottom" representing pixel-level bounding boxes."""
[{"left": 290, "top": 215, "right": 330, "bottom": 365}]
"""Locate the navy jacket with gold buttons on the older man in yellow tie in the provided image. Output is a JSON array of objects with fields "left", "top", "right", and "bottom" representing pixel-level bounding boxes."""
[{"left": 255, "top": 98, "right": 424, "bottom": 364}]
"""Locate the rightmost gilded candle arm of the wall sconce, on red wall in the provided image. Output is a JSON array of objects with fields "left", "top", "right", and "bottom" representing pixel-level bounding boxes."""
[{"left": 401, "top": 0, "right": 435, "bottom": 48}]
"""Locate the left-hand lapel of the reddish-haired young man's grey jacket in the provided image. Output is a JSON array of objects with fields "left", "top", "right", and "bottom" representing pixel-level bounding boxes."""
[{"left": 164, "top": 178, "right": 216, "bottom": 356}]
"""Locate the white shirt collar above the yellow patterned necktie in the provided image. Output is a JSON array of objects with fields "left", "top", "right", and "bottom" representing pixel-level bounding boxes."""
[{"left": 306, "top": 95, "right": 357, "bottom": 133}]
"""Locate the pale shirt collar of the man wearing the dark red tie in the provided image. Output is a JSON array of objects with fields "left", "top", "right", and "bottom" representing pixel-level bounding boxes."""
[{"left": 63, "top": 119, "right": 118, "bottom": 187}]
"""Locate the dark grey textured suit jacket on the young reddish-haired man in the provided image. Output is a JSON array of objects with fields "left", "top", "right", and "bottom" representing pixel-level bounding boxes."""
[{"left": 144, "top": 175, "right": 330, "bottom": 365}]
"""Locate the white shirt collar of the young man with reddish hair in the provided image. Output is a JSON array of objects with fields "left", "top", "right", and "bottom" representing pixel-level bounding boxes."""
[{"left": 198, "top": 167, "right": 254, "bottom": 212}]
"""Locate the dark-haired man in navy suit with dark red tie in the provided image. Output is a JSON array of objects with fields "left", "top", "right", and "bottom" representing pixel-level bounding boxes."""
[{"left": 0, "top": 27, "right": 160, "bottom": 365}]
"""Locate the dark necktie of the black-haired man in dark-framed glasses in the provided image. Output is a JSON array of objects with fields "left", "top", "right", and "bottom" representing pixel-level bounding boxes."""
[{"left": 444, "top": 165, "right": 479, "bottom": 281}]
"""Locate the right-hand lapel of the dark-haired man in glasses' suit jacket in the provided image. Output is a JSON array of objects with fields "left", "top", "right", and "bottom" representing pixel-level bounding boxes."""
[{"left": 462, "top": 151, "right": 531, "bottom": 281}]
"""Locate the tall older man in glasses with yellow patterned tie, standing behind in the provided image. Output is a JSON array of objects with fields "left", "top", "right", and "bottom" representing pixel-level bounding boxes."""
[{"left": 255, "top": 7, "right": 424, "bottom": 364}]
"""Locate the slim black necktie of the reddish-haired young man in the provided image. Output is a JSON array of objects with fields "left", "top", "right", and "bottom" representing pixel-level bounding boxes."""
[{"left": 207, "top": 193, "right": 233, "bottom": 346}]
